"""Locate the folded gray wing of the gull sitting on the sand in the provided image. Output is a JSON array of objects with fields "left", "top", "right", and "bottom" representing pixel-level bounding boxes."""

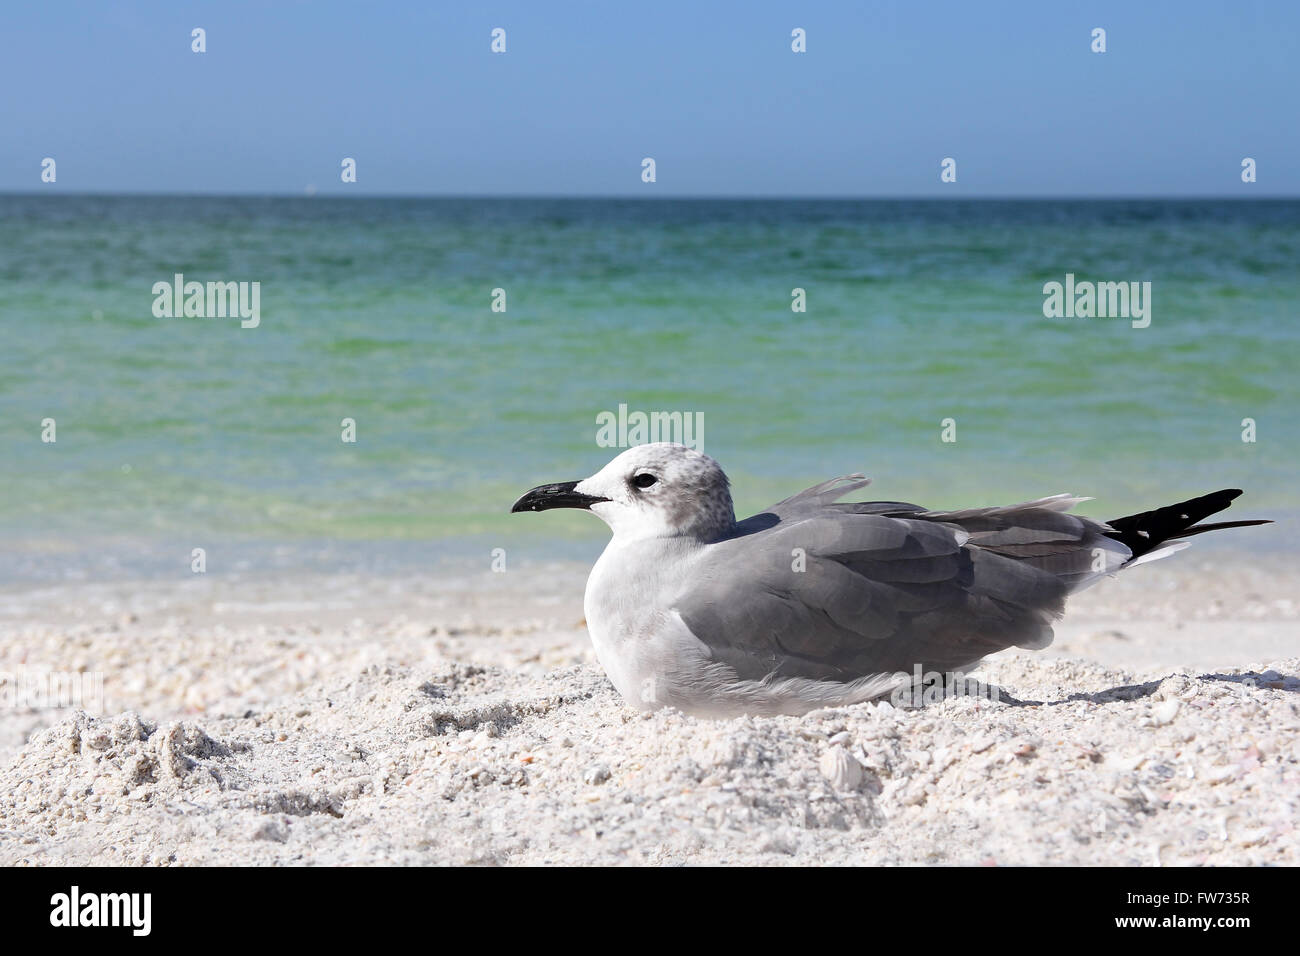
[{"left": 676, "top": 476, "right": 1130, "bottom": 682}]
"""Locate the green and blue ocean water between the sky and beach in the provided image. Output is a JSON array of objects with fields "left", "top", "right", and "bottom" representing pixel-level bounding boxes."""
[{"left": 0, "top": 195, "right": 1300, "bottom": 570}]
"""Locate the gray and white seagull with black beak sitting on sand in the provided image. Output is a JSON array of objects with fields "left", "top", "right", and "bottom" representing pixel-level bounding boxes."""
[{"left": 511, "top": 442, "right": 1269, "bottom": 718}]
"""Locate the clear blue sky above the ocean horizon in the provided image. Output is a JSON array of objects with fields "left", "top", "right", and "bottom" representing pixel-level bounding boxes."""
[{"left": 0, "top": 0, "right": 1300, "bottom": 198}]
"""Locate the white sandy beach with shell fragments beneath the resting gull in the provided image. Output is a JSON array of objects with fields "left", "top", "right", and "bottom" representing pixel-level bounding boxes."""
[{"left": 0, "top": 549, "right": 1300, "bottom": 866}]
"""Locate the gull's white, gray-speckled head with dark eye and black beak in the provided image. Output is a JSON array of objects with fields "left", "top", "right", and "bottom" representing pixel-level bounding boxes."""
[{"left": 511, "top": 441, "right": 736, "bottom": 541}]
